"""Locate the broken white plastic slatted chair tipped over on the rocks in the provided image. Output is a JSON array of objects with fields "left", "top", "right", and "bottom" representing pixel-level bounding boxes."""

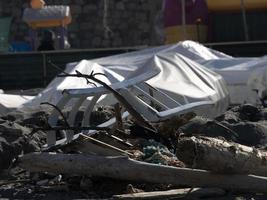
[{"left": 45, "top": 80, "right": 214, "bottom": 147}]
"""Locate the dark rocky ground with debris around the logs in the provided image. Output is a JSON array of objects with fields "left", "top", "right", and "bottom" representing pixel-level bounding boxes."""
[{"left": 0, "top": 105, "right": 267, "bottom": 200}]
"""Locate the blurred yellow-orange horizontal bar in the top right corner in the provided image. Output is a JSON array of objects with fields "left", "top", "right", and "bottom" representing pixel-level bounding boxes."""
[{"left": 206, "top": 0, "right": 267, "bottom": 11}]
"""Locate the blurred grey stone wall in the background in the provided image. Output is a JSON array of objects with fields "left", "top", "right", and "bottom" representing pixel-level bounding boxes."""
[{"left": 0, "top": 0, "right": 164, "bottom": 48}]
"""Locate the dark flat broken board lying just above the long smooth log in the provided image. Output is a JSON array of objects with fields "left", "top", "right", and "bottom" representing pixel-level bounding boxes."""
[{"left": 63, "top": 134, "right": 133, "bottom": 156}]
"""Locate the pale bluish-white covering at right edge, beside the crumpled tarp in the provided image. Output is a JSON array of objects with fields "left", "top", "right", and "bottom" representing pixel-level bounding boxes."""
[{"left": 199, "top": 57, "right": 267, "bottom": 104}]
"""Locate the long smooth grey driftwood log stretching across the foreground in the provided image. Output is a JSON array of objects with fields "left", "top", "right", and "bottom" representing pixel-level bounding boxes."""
[{"left": 18, "top": 153, "right": 267, "bottom": 193}]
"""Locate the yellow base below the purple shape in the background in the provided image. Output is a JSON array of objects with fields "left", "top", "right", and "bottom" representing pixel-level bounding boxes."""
[{"left": 165, "top": 25, "right": 208, "bottom": 44}]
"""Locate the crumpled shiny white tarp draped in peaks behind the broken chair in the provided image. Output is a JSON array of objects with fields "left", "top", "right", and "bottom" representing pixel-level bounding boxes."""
[{"left": 26, "top": 41, "right": 231, "bottom": 117}]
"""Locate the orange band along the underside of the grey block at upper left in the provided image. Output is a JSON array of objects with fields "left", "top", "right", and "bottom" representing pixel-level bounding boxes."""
[{"left": 28, "top": 17, "right": 71, "bottom": 29}]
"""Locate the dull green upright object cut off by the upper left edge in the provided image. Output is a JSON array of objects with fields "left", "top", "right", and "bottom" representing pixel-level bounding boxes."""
[{"left": 0, "top": 17, "right": 12, "bottom": 52}]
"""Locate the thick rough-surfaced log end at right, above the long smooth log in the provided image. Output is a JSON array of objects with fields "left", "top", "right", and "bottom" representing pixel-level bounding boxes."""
[{"left": 176, "top": 137, "right": 267, "bottom": 176}]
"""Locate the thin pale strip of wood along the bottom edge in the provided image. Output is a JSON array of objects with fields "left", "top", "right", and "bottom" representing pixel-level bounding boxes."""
[{"left": 113, "top": 188, "right": 226, "bottom": 200}]
